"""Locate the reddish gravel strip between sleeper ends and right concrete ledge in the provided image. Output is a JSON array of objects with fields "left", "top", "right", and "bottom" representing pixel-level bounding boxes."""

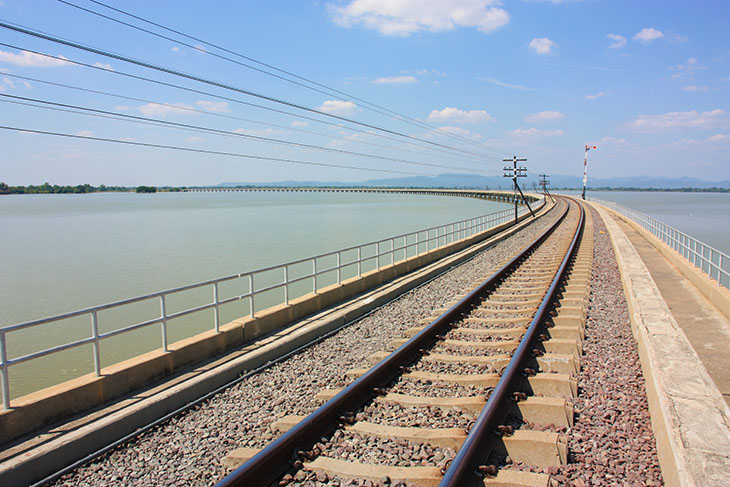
[{"left": 511, "top": 209, "right": 664, "bottom": 487}]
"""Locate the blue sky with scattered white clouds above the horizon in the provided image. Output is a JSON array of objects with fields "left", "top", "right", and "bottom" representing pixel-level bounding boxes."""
[{"left": 0, "top": 0, "right": 730, "bottom": 185}]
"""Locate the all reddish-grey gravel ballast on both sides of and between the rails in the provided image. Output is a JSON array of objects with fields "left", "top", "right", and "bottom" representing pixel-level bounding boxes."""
[{"left": 49, "top": 200, "right": 663, "bottom": 486}]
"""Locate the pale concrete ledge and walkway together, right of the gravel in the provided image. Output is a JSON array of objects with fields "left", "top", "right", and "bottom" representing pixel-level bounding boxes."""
[{"left": 591, "top": 203, "right": 730, "bottom": 487}]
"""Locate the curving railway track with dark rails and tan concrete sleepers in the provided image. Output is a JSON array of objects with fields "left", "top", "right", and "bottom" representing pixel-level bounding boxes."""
[{"left": 218, "top": 196, "right": 592, "bottom": 487}]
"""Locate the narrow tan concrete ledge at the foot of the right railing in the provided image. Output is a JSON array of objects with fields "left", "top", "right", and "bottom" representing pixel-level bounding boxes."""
[{"left": 603, "top": 207, "right": 730, "bottom": 319}]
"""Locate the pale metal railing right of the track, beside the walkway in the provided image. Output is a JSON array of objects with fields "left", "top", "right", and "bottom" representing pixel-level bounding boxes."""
[{"left": 593, "top": 198, "right": 730, "bottom": 288}]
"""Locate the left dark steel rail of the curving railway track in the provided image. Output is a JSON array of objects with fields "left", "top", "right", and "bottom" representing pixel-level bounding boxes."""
[{"left": 216, "top": 198, "right": 569, "bottom": 487}]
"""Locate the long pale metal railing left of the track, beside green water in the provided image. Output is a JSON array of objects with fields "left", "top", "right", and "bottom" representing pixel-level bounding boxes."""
[{"left": 0, "top": 202, "right": 526, "bottom": 409}]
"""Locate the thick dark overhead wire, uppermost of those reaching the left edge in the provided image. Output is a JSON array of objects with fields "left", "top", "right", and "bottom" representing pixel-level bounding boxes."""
[{"left": 0, "top": 21, "right": 500, "bottom": 163}]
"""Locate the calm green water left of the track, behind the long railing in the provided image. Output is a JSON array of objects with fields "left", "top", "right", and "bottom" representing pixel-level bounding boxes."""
[{"left": 0, "top": 192, "right": 511, "bottom": 397}]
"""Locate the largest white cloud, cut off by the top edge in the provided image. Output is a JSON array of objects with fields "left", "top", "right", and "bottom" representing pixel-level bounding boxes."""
[{"left": 327, "top": 0, "right": 509, "bottom": 36}]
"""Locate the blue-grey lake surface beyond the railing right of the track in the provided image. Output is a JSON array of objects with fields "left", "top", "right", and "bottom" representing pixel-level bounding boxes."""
[{"left": 559, "top": 191, "right": 730, "bottom": 255}]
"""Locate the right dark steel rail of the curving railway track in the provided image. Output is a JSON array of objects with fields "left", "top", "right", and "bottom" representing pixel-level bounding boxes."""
[{"left": 439, "top": 197, "right": 585, "bottom": 487}]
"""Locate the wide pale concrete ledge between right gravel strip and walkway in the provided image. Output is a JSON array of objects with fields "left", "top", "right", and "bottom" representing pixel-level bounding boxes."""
[{"left": 593, "top": 204, "right": 730, "bottom": 487}]
